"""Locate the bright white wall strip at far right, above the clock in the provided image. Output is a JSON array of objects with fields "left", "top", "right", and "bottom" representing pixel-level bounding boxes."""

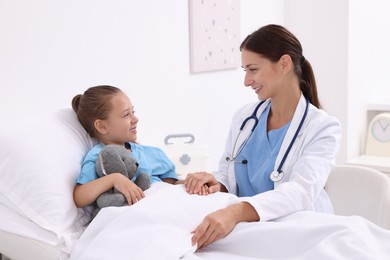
[{"left": 348, "top": 0, "right": 390, "bottom": 158}]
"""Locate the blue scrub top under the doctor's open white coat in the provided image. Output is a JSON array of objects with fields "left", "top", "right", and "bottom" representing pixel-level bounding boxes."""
[{"left": 234, "top": 104, "right": 291, "bottom": 197}]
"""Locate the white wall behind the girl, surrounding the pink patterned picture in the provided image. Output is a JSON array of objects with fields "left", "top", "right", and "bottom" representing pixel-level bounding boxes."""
[{"left": 0, "top": 0, "right": 284, "bottom": 169}]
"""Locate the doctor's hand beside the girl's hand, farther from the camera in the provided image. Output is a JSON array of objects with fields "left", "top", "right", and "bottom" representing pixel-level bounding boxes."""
[{"left": 184, "top": 172, "right": 226, "bottom": 195}]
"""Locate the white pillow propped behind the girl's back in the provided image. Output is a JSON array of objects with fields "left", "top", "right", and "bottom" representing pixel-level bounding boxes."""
[{"left": 0, "top": 108, "right": 95, "bottom": 249}]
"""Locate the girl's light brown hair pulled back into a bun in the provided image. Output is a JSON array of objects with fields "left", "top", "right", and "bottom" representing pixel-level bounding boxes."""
[{"left": 72, "top": 85, "right": 121, "bottom": 138}]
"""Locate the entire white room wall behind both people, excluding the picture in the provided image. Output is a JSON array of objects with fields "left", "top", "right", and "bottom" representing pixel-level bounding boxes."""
[{"left": 0, "top": 0, "right": 390, "bottom": 173}]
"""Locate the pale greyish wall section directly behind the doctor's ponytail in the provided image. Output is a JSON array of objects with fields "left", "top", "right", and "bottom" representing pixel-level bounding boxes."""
[{"left": 285, "top": 0, "right": 350, "bottom": 163}]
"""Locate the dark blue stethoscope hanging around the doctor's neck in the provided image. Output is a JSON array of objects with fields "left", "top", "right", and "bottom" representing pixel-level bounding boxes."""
[{"left": 226, "top": 98, "right": 310, "bottom": 182}]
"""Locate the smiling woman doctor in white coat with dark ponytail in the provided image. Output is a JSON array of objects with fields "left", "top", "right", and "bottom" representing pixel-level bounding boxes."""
[{"left": 184, "top": 25, "right": 341, "bottom": 248}]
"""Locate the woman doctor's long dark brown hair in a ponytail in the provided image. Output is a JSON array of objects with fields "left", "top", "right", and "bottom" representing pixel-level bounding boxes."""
[{"left": 240, "top": 24, "right": 321, "bottom": 108}]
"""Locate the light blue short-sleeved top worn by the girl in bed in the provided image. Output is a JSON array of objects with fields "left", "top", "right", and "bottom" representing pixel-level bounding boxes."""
[{"left": 76, "top": 143, "right": 178, "bottom": 184}]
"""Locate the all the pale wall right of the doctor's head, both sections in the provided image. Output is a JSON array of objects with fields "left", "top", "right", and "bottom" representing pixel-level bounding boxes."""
[{"left": 285, "top": 0, "right": 390, "bottom": 163}]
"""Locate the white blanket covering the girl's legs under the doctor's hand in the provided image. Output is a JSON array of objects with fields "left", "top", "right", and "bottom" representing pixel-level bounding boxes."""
[{"left": 71, "top": 183, "right": 390, "bottom": 260}]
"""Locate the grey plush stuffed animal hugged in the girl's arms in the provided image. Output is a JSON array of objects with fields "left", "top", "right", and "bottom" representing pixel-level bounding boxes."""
[{"left": 92, "top": 144, "right": 150, "bottom": 218}]
